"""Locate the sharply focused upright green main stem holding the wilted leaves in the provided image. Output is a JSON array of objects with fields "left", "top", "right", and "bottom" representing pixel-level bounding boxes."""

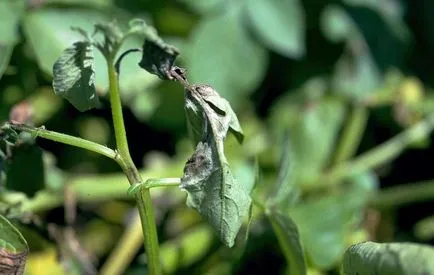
[{"left": 107, "top": 58, "right": 161, "bottom": 275}]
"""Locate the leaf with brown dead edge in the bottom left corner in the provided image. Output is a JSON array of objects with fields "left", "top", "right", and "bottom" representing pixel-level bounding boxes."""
[{"left": 0, "top": 215, "right": 29, "bottom": 275}]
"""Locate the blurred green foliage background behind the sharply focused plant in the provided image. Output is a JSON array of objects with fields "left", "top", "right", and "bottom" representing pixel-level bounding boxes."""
[{"left": 0, "top": 0, "right": 434, "bottom": 274}]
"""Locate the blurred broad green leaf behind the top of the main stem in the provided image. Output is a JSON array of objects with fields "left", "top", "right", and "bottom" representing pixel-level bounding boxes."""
[{"left": 23, "top": 7, "right": 159, "bottom": 106}]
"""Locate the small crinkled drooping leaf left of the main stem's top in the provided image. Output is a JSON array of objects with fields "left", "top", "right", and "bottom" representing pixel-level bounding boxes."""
[{"left": 53, "top": 42, "right": 99, "bottom": 112}]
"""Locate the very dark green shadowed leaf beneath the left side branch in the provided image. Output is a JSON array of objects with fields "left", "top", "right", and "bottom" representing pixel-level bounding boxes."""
[{"left": 6, "top": 144, "right": 46, "bottom": 197}]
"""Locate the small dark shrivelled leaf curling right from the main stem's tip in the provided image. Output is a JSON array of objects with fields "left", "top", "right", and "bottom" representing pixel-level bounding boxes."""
[{"left": 130, "top": 19, "right": 179, "bottom": 79}]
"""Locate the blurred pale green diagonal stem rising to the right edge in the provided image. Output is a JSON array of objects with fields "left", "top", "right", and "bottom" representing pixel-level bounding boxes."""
[{"left": 302, "top": 114, "right": 434, "bottom": 192}]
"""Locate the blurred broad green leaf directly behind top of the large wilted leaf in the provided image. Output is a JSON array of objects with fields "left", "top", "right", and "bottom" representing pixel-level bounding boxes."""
[{"left": 185, "top": 3, "right": 267, "bottom": 105}]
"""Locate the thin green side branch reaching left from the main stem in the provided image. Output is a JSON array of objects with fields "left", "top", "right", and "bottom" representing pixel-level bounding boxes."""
[{"left": 9, "top": 123, "right": 118, "bottom": 161}]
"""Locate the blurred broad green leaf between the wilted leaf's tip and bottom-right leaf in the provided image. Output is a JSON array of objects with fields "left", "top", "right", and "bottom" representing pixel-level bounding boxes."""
[{"left": 289, "top": 174, "right": 377, "bottom": 269}]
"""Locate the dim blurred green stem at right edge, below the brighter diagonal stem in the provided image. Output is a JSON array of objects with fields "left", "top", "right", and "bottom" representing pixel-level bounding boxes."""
[{"left": 369, "top": 180, "right": 434, "bottom": 209}]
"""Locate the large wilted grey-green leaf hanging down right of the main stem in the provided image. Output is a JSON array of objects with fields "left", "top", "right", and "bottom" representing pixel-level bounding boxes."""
[{"left": 180, "top": 85, "right": 251, "bottom": 247}]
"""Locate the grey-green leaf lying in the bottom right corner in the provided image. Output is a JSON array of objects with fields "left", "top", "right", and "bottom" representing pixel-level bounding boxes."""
[{"left": 343, "top": 242, "right": 434, "bottom": 275}]
